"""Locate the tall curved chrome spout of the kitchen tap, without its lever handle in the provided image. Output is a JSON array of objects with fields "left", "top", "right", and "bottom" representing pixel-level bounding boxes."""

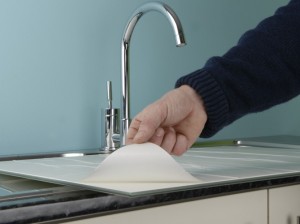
[{"left": 121, "top": 2, "right": 185, "bottom": 145}]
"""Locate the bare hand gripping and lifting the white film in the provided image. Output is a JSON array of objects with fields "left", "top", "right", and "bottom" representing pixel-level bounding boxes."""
[{"left": 126, "top": 85, "right": 207, "bottom": 155}]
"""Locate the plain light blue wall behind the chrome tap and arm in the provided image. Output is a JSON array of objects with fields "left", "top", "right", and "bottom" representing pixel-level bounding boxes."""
[{"left": 0, "top": 0, "right": 292, "bottom": 154}]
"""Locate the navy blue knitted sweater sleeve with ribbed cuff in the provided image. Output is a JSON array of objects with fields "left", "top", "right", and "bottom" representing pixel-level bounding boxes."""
[{"left": 176, "top": 0, "right": 300, "bottom": 137}]
